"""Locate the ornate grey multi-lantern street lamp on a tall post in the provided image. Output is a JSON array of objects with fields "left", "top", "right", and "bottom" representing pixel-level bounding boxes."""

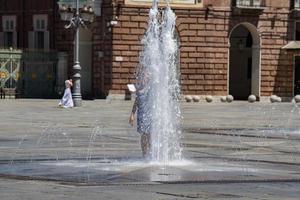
[{"left": 58, "top": 0, "right": 94, "bottom": 107}]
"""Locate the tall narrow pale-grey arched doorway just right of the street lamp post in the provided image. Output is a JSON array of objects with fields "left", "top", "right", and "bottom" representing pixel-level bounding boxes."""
[{"left": 79, "top": 28, "right": 93, "bottom": 99}]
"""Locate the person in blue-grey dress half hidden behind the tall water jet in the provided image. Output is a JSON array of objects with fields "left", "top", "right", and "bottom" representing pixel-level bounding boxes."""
[{"left": 129, "top": 70, "right": 151, "bottom": 157}]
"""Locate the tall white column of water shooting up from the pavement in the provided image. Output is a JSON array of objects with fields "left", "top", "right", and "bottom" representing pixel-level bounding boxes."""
[{"left": 137, "top": 1, "right": 182, "bottom": 164}]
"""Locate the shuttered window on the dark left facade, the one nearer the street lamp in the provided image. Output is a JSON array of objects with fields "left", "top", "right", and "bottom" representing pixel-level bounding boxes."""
[{"left": 28, "top": 15, "right": 49, "bottom": 50}]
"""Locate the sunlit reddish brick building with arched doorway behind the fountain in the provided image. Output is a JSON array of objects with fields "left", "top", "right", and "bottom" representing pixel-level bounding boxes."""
[{"left": 102, "top": 0, "right": 300, "bottom": 99}]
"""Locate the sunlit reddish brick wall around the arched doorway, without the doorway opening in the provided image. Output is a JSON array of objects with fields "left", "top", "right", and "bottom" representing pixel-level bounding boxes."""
[{"left": 106, "top": 0, "right": 293, "bottom": 99}]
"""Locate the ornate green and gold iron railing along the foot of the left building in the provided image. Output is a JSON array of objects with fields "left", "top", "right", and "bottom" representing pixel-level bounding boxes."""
[{"left": 0, "top": 49, "right": 58, "bottom": 98}]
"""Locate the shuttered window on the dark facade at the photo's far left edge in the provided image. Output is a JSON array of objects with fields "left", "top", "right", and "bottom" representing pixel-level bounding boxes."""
[{"left": 0, "top": 15, "right": 17, "bottom": 48}]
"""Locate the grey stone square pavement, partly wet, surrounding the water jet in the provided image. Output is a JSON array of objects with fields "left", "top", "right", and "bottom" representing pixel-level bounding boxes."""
[{"left": 0, "top": 99, "right": 300, "bottom": 200}]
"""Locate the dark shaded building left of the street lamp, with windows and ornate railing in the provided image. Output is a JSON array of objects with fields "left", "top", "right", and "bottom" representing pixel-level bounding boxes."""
[{"left": 0, "top": 0, "right": 57, "bottom": 98}]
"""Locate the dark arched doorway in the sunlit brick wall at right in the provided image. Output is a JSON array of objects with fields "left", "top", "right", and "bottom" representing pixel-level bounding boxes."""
[{"left": 228, "top": 23, "right": 260, "bottom": 100}]
